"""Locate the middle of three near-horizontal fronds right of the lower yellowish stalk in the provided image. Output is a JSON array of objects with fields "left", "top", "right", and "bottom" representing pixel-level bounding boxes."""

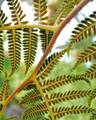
[{"left": 47, "top": 90, "right": 92, "bottom": 104}]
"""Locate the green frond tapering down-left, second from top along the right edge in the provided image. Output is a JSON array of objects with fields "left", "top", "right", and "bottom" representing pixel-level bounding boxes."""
[{"left": 73, "top": 43, "right": 96, "bottom": 69}]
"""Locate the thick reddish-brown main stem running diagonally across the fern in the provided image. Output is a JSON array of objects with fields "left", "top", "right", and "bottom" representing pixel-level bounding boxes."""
[{"left": 5, "top": 0, "right": 90, "bottom": 111}]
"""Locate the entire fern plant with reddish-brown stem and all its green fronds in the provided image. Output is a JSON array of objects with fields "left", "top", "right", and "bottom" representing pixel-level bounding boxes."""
[{"left": 0, "top": 0, "right": 96, "bottom": 120}]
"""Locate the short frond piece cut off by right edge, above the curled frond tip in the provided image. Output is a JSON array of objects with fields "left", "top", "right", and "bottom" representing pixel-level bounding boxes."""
[{"left": 84, "top": 64, "right": 96, "bottom": 79}]
